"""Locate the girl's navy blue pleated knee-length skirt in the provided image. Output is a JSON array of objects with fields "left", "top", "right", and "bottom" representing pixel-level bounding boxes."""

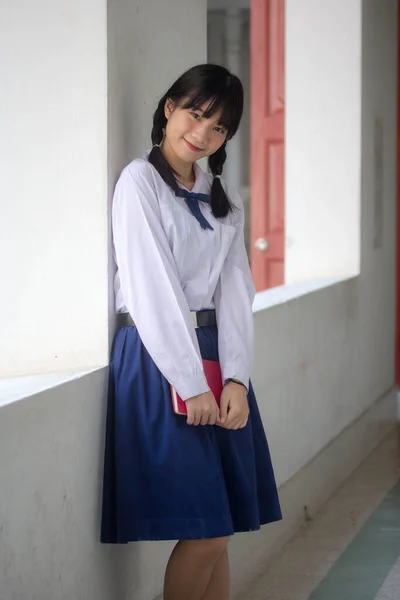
[{"left": 101, "top": 327, "right": 282, "bottom": 543}]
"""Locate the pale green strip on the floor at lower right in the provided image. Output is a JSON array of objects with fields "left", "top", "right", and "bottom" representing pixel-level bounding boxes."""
[{"left": 309, "top": 481, "right": 400, "bottom": 600}]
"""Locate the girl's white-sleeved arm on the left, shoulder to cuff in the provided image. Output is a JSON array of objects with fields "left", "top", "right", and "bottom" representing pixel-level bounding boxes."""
[{"left": 112, "top": 161, "right": 209, "bottom": 399}]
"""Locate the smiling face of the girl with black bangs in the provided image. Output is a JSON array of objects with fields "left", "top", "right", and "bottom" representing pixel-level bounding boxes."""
[{"left": 164, "top": 100, "right": 227, "bottom": 163}]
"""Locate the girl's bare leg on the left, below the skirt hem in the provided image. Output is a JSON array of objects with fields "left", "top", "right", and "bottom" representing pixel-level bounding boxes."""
[{"left": 164, "top": 537, "right": 228, "bottom": 600}]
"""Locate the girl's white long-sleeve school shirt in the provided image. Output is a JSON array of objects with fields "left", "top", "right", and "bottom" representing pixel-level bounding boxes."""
[{"left": 112, "top": 154, "right": 255, "bottom": 400}]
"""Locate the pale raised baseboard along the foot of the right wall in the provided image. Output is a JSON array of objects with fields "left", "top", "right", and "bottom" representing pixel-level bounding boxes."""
[{"left": 230, "top": 388, "right": 400, "bottom": 600}]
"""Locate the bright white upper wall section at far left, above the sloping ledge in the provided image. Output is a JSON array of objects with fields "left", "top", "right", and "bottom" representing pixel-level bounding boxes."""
[{"left": 0, "top": 0, "right": 108, "bottom": 377}]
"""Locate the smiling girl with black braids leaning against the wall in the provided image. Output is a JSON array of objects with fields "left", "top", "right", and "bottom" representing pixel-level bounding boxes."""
[{"left": 101, "top": 65, "right": 281, "bottom": 600}]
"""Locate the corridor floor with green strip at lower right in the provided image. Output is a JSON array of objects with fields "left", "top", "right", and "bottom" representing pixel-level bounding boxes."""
[{"left": 243, "top": 431, "right": 400, "bottom": 600}]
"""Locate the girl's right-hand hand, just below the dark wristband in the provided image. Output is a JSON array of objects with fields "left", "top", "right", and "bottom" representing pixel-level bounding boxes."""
[{"left": 217, "top": 381, "right": 249, "bottom": 429}]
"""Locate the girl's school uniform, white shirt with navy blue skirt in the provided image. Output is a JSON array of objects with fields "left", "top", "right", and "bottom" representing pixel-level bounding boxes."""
[{"left": 101, "top": 153, "right": 281, "bottom": 543}]
